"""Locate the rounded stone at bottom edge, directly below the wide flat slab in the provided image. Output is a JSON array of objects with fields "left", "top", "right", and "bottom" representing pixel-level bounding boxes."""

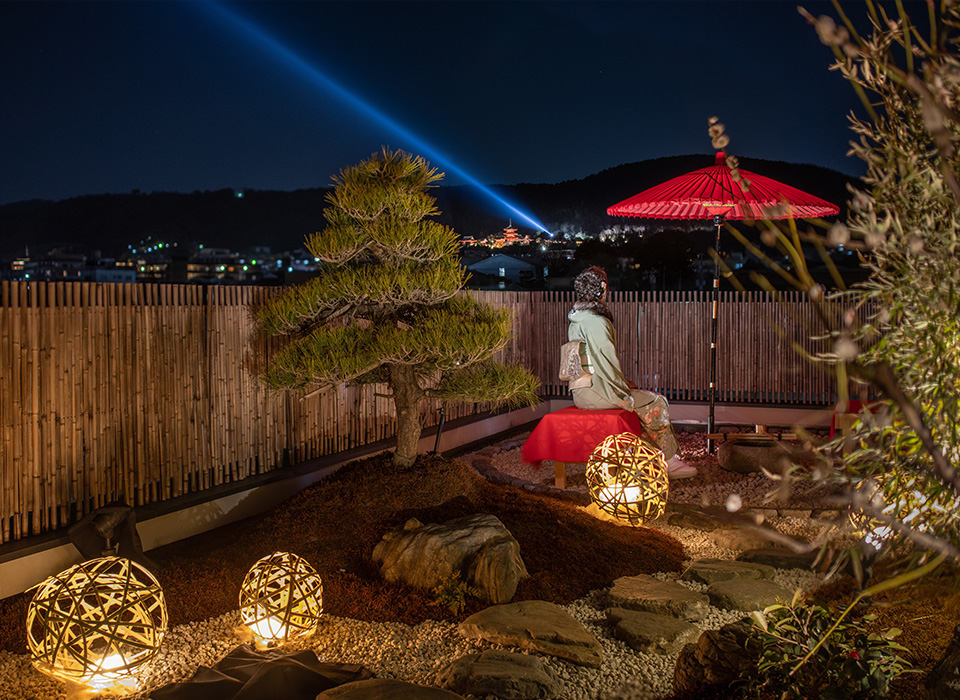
[{"left": 437, "top": 649, "right": 563, "bottom": 700}]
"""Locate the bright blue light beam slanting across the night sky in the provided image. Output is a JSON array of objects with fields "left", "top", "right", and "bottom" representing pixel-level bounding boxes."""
[{"left": 189, "top": 2, "right": 553, "bottom": 235}]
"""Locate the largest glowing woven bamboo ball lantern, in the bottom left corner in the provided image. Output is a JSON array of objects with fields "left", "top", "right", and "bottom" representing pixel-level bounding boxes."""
[{"left": 27, "top": 557, "right": 167, "bottom": 688}]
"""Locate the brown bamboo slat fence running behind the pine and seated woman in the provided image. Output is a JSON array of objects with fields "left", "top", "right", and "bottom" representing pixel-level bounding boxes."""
[{"left": 0, "top": 282, "right": 835, "bottom": 544}]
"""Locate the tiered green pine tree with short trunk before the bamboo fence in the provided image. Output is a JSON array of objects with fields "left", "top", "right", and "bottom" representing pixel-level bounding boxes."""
[{"left": 258, "top": 148, "right": 539, "bottom": 465}]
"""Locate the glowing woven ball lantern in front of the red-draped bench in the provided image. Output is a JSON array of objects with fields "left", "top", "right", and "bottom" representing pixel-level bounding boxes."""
[{"left": 585, "top": 433, "right": 670, "bottom": 525}]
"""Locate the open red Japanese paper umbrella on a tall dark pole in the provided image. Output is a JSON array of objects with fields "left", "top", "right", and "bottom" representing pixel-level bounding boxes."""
[{"left": 607, "top": 152, "right": 840, "bottom": 451}]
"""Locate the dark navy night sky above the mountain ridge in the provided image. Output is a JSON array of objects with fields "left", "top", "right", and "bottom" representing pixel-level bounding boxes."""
[{"left": 0, "top": 0, "right": 900, "bottom": 203}]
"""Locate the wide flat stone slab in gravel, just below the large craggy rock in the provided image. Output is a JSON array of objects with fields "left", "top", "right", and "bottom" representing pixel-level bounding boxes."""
[{"left": 457, "top": 600, "right": 603, "bottom": 668}]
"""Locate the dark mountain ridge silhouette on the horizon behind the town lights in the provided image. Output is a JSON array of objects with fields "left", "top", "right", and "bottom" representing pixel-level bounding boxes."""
[{"left": 0, "top": 155, "right": 860, "bottom": 259}]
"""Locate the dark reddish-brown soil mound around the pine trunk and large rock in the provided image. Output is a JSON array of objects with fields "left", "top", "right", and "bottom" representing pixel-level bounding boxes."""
[{"left": 0, "top": 456, "right": 683, "bottom": 654}]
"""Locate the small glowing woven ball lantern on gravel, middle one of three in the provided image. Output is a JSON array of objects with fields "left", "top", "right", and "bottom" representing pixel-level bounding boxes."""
[{"left": 240, "top": 552, "right": 323, "bottom": 645}]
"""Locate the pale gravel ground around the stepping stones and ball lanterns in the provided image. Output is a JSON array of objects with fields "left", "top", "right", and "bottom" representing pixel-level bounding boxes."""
[{"left": 0, "top": 434, "right": 819, "bottom": 700}]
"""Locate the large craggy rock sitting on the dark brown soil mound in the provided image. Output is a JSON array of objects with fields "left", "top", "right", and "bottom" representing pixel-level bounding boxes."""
[{"left": 373, "top": 513, "right": 528, "bottom": 603}]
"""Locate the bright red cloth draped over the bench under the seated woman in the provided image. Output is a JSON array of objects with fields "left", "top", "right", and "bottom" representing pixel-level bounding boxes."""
[{"left": 520, "top": 406, "right": 643, "bottom": 464}]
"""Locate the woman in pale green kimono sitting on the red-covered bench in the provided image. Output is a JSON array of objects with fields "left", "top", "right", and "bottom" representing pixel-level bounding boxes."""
[{"left": 567, "top": 267, "right": 697, "bottom": 479}]
